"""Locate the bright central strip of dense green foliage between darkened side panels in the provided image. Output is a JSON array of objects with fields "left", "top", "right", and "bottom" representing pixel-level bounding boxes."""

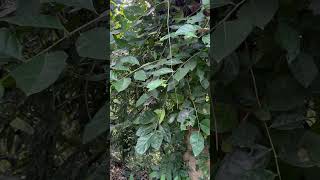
[{"left": 110, "top": 0, "right": 210, "bottom": 179}]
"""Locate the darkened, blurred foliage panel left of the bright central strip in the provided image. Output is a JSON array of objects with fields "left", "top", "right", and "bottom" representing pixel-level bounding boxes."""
[{"left": 0, "top": 0, "right": 109, "bottom": 180}]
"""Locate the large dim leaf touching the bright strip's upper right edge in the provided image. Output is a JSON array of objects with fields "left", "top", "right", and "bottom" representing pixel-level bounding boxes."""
[{"left": 210, "top": 19, "right": 252, "bottom": 63}]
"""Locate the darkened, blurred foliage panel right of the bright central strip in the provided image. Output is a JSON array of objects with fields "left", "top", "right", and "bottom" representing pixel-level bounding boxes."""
[{"left": 210, "top": 0, "right": 320, "bottom": 180}]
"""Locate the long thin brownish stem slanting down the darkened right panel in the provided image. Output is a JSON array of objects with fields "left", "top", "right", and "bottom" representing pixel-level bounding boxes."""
[{"left": 250, "top": 68, "right": 282, "bottom": 180}]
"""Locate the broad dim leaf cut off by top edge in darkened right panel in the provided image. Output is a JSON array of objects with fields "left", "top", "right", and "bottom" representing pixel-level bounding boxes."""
[{"left": 238, "top": 0, "right": 279, "bottom": 29}]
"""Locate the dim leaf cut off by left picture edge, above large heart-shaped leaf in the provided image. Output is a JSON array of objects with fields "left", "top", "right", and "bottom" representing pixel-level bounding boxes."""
[{"left": 0, "top": 28, "right": 23, "bottom": 59}]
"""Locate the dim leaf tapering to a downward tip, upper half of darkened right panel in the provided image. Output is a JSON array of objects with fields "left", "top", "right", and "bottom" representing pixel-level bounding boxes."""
[{"left": 275, "top": 22, "right": 300, "bottom": 64}]
